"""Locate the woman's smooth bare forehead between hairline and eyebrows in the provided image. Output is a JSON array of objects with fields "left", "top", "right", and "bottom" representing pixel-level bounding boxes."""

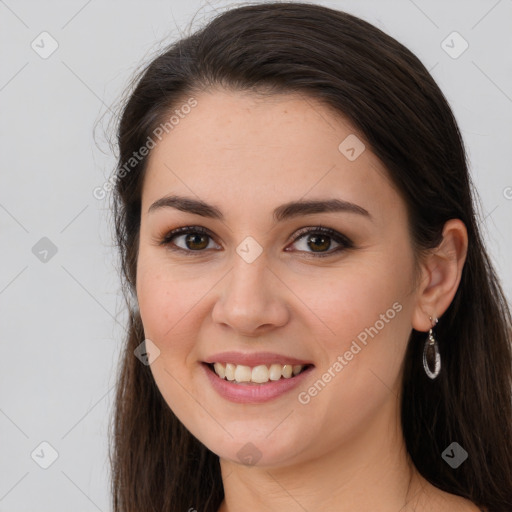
[{"left": 143, "top": 90, "right": 399, "bottom": 224}]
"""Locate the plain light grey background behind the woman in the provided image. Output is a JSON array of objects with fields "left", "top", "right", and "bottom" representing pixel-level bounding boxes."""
[{"left": 0, "top": 0, "right": 512, "bottom": 512}]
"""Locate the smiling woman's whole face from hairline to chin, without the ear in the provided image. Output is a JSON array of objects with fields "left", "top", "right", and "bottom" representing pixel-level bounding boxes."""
[{"left": 137, "top": 90, "right": 416, "bottom": 466}]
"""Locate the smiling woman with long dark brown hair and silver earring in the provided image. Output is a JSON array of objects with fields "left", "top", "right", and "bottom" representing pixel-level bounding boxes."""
[{"left": 106, "top": 3, "right": 512, "bottom": 512}]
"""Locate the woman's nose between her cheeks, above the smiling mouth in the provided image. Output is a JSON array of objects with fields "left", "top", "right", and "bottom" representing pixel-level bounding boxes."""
[{"left": 212, "top": 254, "right": 289, "bottom": 337}]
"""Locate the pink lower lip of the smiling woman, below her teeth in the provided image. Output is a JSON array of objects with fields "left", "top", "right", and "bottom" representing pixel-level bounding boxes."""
[{"left": 201, "top": 363, "right": 314, "bottom": 404}]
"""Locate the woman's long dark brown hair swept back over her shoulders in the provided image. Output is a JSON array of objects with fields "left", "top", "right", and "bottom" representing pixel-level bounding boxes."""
[{"left": 106, "top": 3, "right": 512, "bottom": 512}]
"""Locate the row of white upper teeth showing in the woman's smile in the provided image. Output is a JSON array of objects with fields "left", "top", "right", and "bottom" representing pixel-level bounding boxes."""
[{"left": 213, "top": 363, "right": 304, "bottom": 384}]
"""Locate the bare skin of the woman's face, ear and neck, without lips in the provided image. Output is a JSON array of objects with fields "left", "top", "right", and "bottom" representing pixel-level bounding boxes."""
[{"left": 137, "top": 90, "right": 478, "bottom": 512}]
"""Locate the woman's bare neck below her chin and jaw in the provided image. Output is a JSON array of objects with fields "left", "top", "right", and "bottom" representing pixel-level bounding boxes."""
[{"left": 219, "top": 393, "right": 432, "bottom": 512}]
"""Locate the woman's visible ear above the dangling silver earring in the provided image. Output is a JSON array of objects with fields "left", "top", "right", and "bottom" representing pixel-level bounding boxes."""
[{"left": 412, "top": 219, "right": 468, "bottom": 332}]
